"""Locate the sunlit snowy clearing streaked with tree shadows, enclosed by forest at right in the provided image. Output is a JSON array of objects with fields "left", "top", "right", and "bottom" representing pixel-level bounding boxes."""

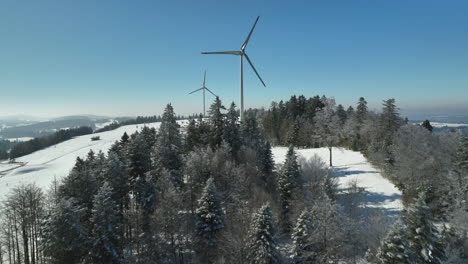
[{"left": 272, "top": 147, "right": 403, "bottom": 216}]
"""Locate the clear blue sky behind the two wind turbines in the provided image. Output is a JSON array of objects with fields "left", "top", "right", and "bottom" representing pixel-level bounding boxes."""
[{"left": 0, "top": 0, "right": 468, "bottom": 116}]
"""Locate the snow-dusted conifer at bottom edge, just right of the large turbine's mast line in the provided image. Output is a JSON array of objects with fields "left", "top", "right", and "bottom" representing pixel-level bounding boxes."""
[{"left": 247, "top": 204, "right": 281, "bottom": 264}]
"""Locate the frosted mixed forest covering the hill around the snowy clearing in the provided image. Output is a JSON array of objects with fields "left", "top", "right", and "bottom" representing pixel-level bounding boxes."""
[{"left": 0, "top": 96, "right": 468, "bottom": 264}]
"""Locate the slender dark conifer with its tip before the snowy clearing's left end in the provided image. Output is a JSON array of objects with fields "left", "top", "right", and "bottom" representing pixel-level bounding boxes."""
[{"left": 278, "top": 146, "right": 300, "bottom": 233}]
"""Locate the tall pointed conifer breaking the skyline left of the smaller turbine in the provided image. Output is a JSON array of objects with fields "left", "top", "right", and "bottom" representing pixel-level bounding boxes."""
[{"left": 153, "top": 104, "right": 183, "bottom": 186}]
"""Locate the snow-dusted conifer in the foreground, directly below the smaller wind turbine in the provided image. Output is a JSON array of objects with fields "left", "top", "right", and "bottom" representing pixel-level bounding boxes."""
[{"left": 195, "top": 178, "right": 224, "bottom": 261}]
